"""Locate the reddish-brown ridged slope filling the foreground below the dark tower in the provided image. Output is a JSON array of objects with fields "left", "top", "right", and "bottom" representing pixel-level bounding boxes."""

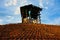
[{"left": 0, "top": 24, "right": 60, "bottom": 40}]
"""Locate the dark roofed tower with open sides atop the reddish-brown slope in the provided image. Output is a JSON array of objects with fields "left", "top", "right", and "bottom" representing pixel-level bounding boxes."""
[{"left": 20, "top": 4, "right": 42, "bottom": 23}]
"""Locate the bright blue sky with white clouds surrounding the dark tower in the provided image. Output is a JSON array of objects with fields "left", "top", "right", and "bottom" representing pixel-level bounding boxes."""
[{"left": 0, "top": 0, "right": 60, "bottom": 25}]
